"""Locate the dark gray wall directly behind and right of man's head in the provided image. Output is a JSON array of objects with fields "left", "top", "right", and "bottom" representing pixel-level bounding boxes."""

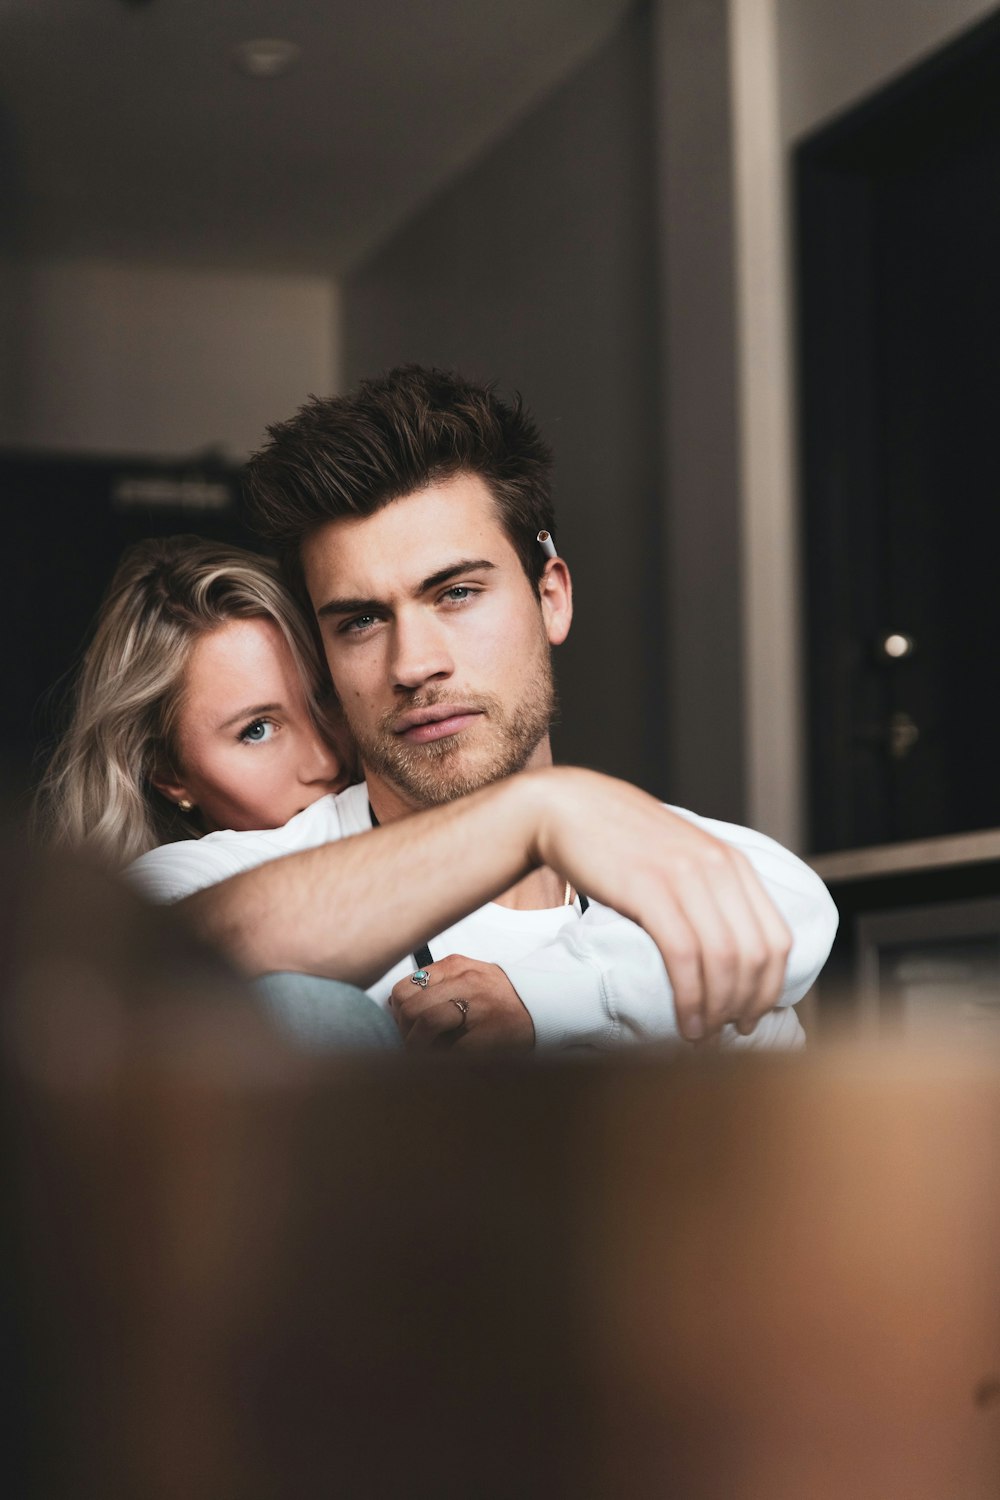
[{"left": 342, "top": 12, "right": 669, "bottom": 795}]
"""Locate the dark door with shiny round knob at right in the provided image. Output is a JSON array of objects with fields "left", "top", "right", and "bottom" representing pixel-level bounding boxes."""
[{"left": 798, "top": 8, "right": 1000, "bottom": 849}]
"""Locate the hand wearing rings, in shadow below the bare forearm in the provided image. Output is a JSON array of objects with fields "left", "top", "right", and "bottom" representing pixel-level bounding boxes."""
[{"left": 388, "top": 954, "right": 535, "bottom": 1052}]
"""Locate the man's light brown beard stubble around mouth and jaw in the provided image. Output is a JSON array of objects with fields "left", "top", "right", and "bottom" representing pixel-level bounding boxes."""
[{"left": 351, "top": 656, "right": 556, "bottom": 807}]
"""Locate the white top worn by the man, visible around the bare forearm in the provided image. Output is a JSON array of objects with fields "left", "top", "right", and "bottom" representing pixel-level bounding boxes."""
[{"left": 127, "top": 783, "right": 837, "bottom": 1047}]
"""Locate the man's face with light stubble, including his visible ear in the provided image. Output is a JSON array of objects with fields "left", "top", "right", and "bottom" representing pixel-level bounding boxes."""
[{"left": 303, "top": 474, "right": 571, "bottom": 816}]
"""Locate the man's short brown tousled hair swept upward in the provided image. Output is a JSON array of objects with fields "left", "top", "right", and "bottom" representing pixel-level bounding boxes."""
[{"left": 246, "top": 365, "right": 553, "bottom": 596}]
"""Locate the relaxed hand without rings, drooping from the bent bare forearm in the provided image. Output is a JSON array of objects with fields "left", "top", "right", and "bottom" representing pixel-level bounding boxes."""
[{"left": 538, "top": 768, "right": 792, "bottom": 1041}]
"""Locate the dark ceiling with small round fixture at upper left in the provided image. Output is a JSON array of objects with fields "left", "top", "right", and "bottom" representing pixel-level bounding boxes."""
[{"left": 0, "top": 0, "right": 630, "bottom": 275}]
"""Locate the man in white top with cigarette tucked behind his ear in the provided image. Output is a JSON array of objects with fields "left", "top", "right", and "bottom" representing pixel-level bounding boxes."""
[{"left": 136, "top": 366, "right": 835, "bottom": 1049}]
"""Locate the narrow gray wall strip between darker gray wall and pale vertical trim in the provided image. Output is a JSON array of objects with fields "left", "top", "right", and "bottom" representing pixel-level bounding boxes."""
[{"left": 651, "top": 0, "right": 748, "bottom": 822}]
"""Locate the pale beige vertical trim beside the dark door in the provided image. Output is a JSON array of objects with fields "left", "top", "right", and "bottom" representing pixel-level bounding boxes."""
[{"left": 730, "top": 0, "right": 805, "bottom": 848}]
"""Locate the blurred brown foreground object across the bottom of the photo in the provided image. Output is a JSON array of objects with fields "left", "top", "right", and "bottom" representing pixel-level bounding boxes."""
[{"left": 4, "top": 846, "right": 1000, "bottom": 1500}]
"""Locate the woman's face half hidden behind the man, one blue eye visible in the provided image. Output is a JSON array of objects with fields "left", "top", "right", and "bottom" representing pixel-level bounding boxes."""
[{"left": 156, "top": 620, "right": 346, "bottom": 831}]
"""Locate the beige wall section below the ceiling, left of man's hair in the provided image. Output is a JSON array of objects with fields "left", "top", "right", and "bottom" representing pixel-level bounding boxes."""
[{"left": 0, "top": 261, "right": 339, "bottom": 458}]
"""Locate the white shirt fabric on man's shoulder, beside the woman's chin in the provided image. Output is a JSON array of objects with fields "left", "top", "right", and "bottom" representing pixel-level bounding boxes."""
[{"left": 126, "top": 785, "right": 370, "bottom": 902}]
